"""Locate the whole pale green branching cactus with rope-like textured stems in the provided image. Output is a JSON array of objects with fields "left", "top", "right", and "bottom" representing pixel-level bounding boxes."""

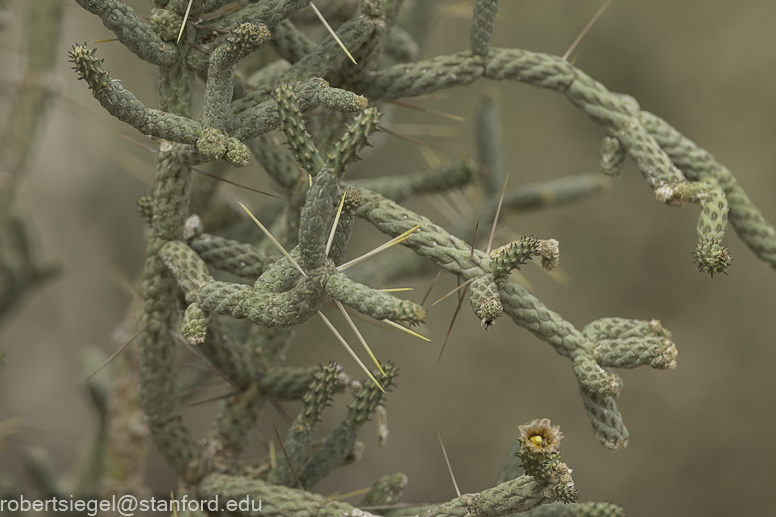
[{"left": 56, "top": 0, "right": 776, "bottom": 517}]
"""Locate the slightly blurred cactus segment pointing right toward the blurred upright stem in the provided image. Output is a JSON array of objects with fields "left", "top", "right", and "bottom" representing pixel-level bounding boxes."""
[{"left": 358, "top": 160, "right": 479, "bottom": 202}]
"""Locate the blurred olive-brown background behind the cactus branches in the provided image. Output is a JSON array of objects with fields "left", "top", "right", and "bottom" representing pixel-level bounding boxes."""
[{"left": 0, "top": 0, "right": 776, "bottom": 516}]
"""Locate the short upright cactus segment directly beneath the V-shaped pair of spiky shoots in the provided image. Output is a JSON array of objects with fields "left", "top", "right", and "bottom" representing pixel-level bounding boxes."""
[{"left": 299, "top": 169, "right": 340, "bottom": 273}]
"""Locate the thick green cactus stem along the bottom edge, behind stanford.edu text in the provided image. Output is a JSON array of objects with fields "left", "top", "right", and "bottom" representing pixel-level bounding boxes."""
[{"left": 199, "top": 474, "right": 360, "bottom": 517}]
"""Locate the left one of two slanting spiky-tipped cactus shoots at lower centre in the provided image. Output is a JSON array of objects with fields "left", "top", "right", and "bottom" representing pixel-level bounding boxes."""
[{"left": 268, "top": 363, "right": 342, "bottom": 486}]
